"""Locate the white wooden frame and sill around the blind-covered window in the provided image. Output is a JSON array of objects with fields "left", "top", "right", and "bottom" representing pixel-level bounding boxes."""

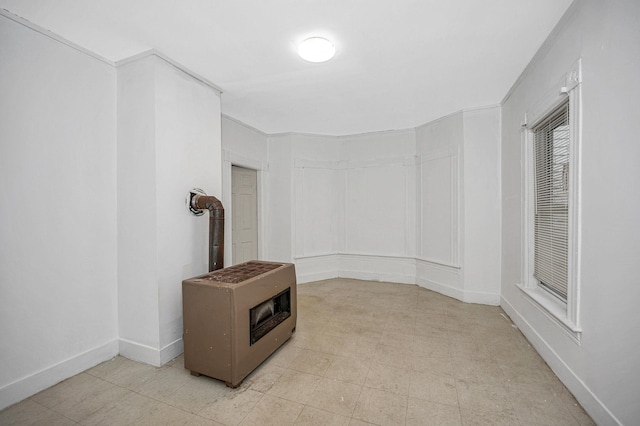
[{"left": 518, "top": 59, "right": 582, "bottom": 344}]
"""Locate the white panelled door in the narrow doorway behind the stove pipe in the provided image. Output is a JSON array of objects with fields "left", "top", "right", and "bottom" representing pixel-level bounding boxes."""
[{"left": 231, "top": 166, "right": 258, "bottom": 265}]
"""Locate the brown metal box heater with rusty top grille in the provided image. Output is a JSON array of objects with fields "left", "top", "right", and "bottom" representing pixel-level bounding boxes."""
[{"left": 182, "top": 261, "right": 297, "bottom": 388}]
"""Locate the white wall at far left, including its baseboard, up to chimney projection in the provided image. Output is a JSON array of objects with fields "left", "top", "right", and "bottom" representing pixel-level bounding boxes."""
[{"left": 0, "top": 15, "right": 118, "bottom": 409}]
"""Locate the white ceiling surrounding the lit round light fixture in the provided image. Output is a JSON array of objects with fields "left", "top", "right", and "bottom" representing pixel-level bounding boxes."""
[{"left": 0, "top": 0, "right": 572, "bottom": 135}]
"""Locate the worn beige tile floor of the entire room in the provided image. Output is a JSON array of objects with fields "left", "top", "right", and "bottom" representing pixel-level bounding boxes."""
[{"left": 0, "top": 279, "right": 594, "bottom": 426}]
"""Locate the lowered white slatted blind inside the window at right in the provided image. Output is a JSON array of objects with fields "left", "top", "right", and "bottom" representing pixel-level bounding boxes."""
[{"left": 533, "top": 102, "right": 570, "bottom": 301}]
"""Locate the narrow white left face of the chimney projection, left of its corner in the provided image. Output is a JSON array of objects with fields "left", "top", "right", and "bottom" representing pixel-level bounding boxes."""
[{"left": 117, "top": 52, "right": 160, "bottom": 363}]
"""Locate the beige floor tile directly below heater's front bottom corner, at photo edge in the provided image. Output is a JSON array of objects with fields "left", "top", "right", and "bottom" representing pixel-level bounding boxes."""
[{"left": 198, "top": 388, "right": 264, "bottom": 425}]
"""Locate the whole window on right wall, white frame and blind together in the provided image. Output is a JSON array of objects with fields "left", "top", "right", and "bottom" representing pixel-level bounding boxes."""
[{"left": 519, "top": 60, "right": 581, "bottom": 344}]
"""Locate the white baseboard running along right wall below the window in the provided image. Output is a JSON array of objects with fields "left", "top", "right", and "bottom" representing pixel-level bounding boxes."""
[{"left": 500, "top": 297, "right": 622, "bottom": 425}]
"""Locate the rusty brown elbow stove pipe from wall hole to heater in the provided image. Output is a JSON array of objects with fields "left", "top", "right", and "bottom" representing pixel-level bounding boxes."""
[{"left": 186, "top": 188, "right": 224, "bottom": 272}]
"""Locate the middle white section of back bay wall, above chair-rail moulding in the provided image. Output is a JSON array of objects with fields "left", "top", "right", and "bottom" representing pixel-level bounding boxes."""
[{"left": 340, "top": 129, "right": 415, "bottom": 257}]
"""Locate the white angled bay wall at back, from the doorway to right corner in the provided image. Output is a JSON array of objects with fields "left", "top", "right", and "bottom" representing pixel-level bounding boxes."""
[{"left": 245, "top": 120, "right": 500, "bottom": 305}]
